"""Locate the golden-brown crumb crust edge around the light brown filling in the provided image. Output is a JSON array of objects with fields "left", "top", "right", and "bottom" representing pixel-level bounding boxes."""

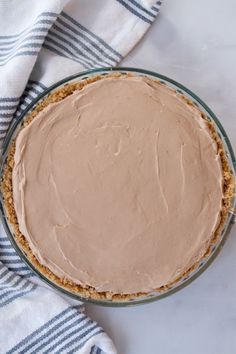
[{"left": 0, "top": 73, "right": 235, "bottom": 302}]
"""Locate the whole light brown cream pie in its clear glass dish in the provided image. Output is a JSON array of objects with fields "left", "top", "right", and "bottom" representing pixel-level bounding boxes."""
[{"left": 1, "top": 68, "right": 235, "bottom": 305}]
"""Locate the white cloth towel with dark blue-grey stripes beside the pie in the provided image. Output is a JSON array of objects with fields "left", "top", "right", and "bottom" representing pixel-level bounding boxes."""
[{"left": 0, "top": 0, "right": 161, "bottom": 354}]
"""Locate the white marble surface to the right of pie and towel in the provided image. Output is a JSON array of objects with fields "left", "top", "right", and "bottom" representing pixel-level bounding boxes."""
[{"left": 87, "top": 0, "right": 236, "bottom": 354}]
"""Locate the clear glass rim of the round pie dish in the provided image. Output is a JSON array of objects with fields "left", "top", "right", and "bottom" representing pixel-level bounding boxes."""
[{"left": 0, "top": 67, "right": 236, "bottom": 307}]
